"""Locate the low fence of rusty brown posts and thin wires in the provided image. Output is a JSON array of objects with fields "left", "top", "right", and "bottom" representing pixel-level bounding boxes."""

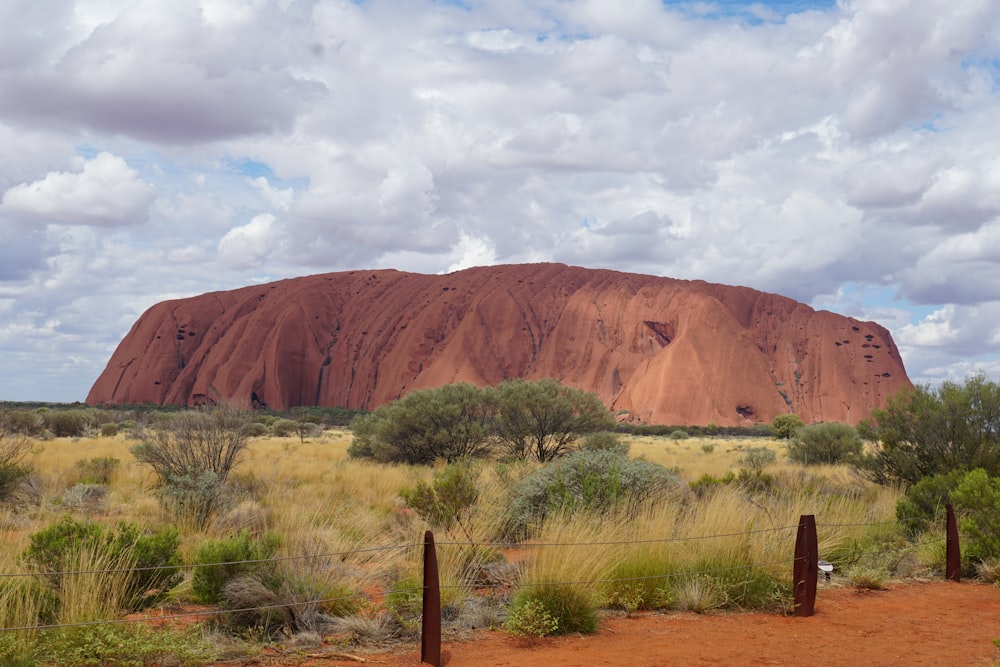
[{"left": 0, "top": 503, "right": 961, "bottom": 667}]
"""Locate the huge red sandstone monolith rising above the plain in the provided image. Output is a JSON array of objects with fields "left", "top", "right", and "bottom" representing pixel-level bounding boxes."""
[{"left": 87, "top": 264, "right": 910, "bottom": 425}]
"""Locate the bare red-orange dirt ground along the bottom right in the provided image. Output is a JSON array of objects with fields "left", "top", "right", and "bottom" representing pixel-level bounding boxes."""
[{"left": 264, "top": 581, "right": 1000, "bottom": 667}]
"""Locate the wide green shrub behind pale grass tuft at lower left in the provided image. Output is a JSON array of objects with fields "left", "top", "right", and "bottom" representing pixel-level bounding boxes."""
[{"left": 21, "top": 516, "right": 182, "bottom": 610}]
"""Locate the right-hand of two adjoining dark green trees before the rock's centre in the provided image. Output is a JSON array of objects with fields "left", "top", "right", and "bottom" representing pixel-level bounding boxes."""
[{"left": 495, "top": 378, "right": 615, "bottom": 463}]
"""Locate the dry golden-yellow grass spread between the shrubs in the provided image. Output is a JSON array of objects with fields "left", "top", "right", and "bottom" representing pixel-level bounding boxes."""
[{"left": 0, "top": 430, "right": 899, "bottom": 623}]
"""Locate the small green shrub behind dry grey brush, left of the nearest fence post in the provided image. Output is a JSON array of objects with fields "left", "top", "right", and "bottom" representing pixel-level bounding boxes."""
[{"left": 191, "top": 530, "right": 279, "bottom": 604}]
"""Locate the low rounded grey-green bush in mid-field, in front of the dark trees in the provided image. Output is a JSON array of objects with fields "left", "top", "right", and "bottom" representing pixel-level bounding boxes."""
[{"left": 512, "top": 450, "right": 682, "bottom": 529}]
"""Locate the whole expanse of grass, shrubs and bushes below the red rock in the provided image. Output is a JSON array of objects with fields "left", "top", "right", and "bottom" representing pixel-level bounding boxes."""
[{"left": 0, "top": 380, "right": 1000, "bottom": 665}]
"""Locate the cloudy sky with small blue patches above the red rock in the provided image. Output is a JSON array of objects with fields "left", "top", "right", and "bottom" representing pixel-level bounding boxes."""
[{"left": 0, "top": 0, "right": 1000, "bottom": 402}]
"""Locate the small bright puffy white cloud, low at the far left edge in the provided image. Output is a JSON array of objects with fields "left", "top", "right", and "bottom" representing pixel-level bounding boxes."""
[{"left": 0, "top": 153, "right": 156, "bottom": 227}]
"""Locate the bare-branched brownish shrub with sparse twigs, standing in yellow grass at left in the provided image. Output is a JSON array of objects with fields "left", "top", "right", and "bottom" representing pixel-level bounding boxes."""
[{"left": 131, "top": 407, "right": 251, "bottom": 527}]
